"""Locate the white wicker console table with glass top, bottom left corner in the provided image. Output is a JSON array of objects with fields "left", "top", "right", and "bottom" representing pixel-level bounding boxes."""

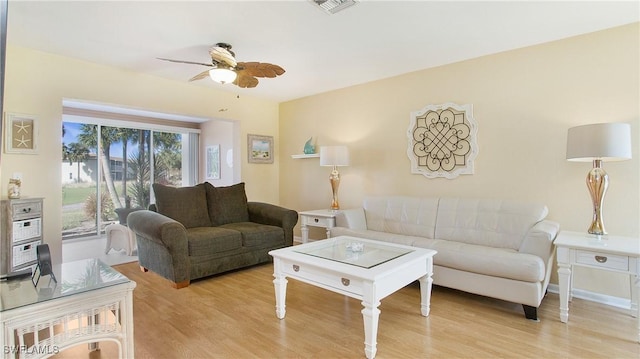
[{"left": 0, "top": 259, "right": 136, "bottom": 358}]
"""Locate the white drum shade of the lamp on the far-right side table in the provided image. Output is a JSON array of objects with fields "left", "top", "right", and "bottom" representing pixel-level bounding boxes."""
[{"left": 567, "top": 123, "right": 631, "bottom": 162}]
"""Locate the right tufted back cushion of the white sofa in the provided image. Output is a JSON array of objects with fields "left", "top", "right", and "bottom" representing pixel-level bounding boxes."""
[{"left": 435, "top": 198, "right": 548, "bottom": 250}]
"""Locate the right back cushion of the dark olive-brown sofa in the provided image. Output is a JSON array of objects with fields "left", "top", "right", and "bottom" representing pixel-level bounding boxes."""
[{"left": 204, "top": 182, "right": 249, "bottom": 226}]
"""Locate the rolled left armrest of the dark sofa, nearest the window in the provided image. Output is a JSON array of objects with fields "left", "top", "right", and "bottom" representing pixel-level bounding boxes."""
[{"left": 127, "top": 210, "right": 188, "bottom": 253}]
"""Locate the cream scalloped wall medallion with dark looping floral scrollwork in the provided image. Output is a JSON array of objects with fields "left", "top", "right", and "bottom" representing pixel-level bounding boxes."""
[{"left": 407, "top": 103, "right": 478, "bottom": 179}]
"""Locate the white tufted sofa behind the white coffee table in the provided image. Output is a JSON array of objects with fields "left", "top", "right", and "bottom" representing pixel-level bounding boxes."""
[{"left": 331, "top": 196, "right": 560, "bottom": 320}]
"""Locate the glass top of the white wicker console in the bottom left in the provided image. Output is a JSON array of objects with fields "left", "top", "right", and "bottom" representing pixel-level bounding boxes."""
[{"left": 0, "top": 259, "right": 129, "bottom": 311}]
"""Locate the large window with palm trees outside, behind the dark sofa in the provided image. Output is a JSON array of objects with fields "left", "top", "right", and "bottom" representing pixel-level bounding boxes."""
[{"left": 62, "top": 108, "right": 199, "bottom": 240}]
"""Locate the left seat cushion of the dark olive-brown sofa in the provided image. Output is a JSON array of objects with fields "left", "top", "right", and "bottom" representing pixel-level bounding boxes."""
[{"left": 187, "top": 227, "right": 242, "bottom": 257}]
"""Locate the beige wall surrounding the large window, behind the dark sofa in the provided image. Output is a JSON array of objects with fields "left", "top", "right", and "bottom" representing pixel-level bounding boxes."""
[{"left": 0, "top": 44, "right": 279, "bottom": 262}]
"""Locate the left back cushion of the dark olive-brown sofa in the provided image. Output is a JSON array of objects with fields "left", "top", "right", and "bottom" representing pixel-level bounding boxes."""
[{"left": 153, "top": 183, "right": 211, "bottom": 228}]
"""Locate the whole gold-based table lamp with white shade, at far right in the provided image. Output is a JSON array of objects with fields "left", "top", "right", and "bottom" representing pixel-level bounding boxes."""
[{"left": 567, "top": 123, "right": 631, "bottom": 235}]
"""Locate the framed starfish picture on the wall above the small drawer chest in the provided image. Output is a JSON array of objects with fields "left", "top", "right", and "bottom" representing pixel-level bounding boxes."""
[{"left": 4, "top": 113, "right": 38, "bottom": 154}]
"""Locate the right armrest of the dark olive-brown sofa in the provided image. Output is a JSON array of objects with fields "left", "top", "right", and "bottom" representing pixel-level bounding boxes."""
[{"left": 247, "top": 202, "right": 298, "bottom": 246}]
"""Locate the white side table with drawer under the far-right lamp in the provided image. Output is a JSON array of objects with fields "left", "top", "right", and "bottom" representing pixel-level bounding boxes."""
[{"left": 554, "top": 231, "right": 640, "bottom": 343}]
